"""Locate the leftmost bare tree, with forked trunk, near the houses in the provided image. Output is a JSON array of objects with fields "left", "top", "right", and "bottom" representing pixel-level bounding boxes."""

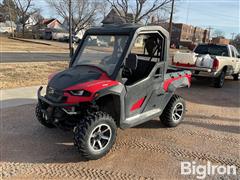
[{"left": 14, "top": 0, "right": 36, "bottom": 37}]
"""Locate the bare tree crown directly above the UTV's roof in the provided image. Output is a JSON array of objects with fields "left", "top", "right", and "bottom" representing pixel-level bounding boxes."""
[{"left": 107, "top": 0, "right": 172, "bottom": 23}]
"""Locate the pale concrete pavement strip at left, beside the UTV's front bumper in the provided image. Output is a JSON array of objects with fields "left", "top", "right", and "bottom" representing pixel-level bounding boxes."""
[{"left": 0, "top": 86, "right": 46, "bottom": 109}]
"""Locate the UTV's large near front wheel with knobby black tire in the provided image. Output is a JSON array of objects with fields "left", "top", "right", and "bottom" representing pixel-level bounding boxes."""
[{"left": 73, "top": 111, "right": 117, "bottom": 160}]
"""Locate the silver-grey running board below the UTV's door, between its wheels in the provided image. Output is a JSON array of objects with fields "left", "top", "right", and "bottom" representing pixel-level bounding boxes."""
[{"left": 121, "top": 108, "right": 161, "bottom": 129}]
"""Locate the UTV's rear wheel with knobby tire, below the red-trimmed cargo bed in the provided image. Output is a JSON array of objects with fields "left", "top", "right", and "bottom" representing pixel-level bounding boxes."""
[{"left": 160, "top": 94, "right": 186, "bottom": 127}]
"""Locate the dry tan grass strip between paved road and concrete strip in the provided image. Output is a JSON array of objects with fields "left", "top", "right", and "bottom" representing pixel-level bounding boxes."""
[{"left": 0, "top": 61, "right": 68, "bottom": 89}]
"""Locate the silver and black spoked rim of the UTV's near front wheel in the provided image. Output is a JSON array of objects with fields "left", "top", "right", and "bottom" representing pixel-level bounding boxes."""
[{"left": 89, "top": 124, "right": 112, "bottom": 151}]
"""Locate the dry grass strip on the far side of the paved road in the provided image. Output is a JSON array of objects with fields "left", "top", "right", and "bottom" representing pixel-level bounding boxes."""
[{"left": 0, "top": 36, "right": 68, "bottom": 52}]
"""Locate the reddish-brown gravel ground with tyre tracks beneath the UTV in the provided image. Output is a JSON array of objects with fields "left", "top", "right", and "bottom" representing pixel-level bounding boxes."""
[{"left": 0, "top": 79, "right": 240, "bottom": 179}]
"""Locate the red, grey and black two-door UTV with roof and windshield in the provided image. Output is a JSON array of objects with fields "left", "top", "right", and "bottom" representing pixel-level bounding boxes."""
[{"left": 36, "top": 25, "right": 191, "bottom": 159}]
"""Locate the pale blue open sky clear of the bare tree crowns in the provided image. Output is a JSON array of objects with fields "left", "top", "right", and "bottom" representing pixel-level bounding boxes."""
[{"left": 0, "top": 0, "right": 240, "bottom": 38}]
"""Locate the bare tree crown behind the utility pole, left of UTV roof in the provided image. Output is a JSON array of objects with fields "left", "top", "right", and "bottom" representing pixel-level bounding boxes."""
[{"left": 46, "top": 0, "right": 100, "bottom": 32}]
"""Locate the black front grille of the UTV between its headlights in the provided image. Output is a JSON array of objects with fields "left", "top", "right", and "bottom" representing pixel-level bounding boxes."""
[{"left": 46, "top": 86, "right": 67, "bottom": 103}]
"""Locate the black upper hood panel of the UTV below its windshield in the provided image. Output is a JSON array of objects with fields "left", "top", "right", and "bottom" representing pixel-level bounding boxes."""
[{"left": 48, "top": 66, "right": 103, "bottom": 90}]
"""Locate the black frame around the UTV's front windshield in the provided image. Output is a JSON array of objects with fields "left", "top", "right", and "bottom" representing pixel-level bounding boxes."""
[{"left": 69, "top": 31, "right": 134, "bottom": 79}]
